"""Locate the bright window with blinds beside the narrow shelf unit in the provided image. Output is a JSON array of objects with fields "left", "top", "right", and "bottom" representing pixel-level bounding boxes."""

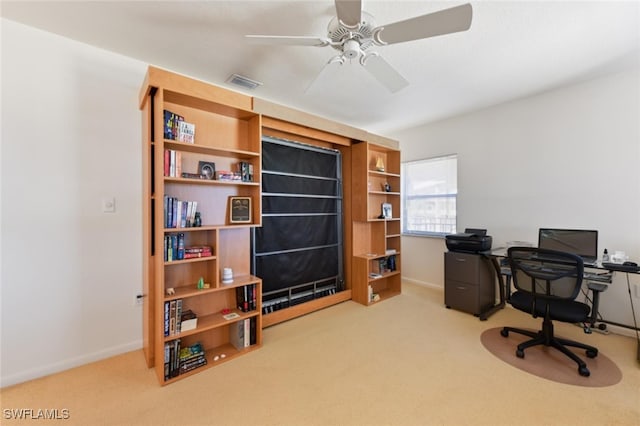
[{"left": 401, "top": 154, "right": 458, "bottom": 235}]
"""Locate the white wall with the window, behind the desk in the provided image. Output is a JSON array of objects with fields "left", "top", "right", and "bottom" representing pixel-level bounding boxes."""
[{"left": 393, "top": 68, "right": 640, "bottom": 325}]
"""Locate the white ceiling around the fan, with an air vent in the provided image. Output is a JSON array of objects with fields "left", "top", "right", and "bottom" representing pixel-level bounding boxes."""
[{"left": 0, "top": 0, "right": 640, "bottom": 134}]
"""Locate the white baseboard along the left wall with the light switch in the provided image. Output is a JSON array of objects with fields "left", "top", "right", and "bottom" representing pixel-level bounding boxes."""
[{"left": 0, "top": 340, "right": 142, "bottom": 388}]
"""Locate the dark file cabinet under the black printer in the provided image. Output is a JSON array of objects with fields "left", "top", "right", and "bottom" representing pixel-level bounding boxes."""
[{"left": 444, "top": 251, "right": 496, "bottom": 316}]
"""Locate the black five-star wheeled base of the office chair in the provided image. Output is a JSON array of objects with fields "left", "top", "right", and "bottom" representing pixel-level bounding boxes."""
[{"left": 500, "top": 318, "right": 598, "bottom": 377}]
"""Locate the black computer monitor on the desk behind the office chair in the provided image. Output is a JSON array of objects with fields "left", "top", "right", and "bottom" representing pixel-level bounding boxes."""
[{"left": 538, "top": 228, "right": 598, "bottom": 263}]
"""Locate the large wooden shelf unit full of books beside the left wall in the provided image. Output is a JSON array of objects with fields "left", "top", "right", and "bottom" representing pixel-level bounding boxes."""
[{"left": 140, "top": 67, "right": 262, "bottom": 385}]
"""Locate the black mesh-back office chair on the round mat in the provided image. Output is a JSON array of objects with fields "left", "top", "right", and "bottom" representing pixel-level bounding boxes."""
[{"left": 500, "top": 247, "right": 598, "bottom": 377}]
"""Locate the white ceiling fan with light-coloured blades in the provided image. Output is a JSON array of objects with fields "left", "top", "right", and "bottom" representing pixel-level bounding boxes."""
[{"left": 245, "top": 0, "right": 473, "bottom": 93}]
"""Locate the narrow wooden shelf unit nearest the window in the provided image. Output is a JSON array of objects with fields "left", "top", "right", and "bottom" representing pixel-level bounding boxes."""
[{"left": 352, "top": 142, "right": 402, "bottom": 305}]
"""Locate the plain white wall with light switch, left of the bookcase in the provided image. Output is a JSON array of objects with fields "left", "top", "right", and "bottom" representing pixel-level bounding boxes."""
[{"left": 0, "top": 19, "right": 146, "bottom": 386}]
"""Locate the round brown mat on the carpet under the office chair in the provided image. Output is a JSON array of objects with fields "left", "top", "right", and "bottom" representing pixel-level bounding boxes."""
[{"left": 480, "top": 327, "right": 622, "bottom": 387}]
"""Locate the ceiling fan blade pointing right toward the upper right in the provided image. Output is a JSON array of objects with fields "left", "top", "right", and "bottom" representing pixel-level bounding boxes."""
[{"left": 375, "top": 3, "right": 473, "bottom": 44}]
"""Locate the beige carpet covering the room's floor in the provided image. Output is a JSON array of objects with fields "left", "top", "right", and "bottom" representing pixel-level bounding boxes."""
[{"left": 0, "top": 283, "right": 640, "bottom": 426}]
